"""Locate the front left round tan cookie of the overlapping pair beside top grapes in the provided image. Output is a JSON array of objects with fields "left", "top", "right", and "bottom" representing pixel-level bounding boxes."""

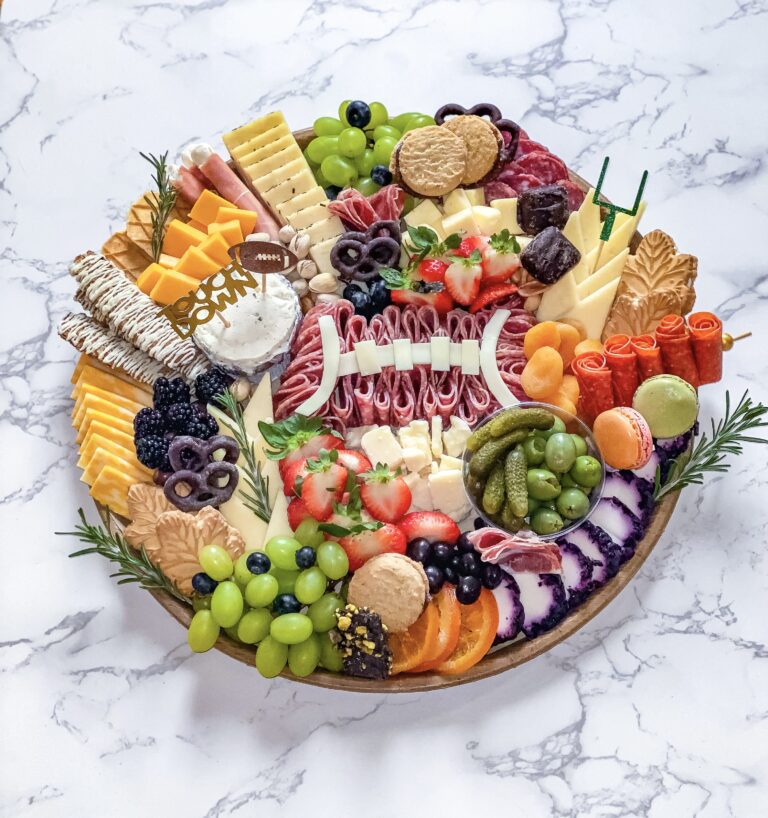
[{"left": 390, "top": 125, "right": 467, "bottom": 198}]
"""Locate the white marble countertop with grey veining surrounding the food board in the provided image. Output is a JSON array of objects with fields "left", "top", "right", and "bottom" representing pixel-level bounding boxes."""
[{"left": 0, "top": 0, "right": 768, "bottom": 818}]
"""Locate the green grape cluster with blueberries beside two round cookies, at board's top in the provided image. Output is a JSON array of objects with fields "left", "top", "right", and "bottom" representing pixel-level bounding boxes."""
[{"left": 304, "top": 99, "right": 435, "bottom": 193}]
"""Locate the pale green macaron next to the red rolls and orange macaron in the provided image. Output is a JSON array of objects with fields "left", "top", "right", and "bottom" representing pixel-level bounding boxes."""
[{"left": 632, "top": 375, "right": 699, "bottom": 437}]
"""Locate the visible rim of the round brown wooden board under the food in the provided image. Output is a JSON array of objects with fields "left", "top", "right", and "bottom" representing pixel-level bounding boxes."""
[{"left": 96, "top": 128, "right": 679, "bottom": 693}]
